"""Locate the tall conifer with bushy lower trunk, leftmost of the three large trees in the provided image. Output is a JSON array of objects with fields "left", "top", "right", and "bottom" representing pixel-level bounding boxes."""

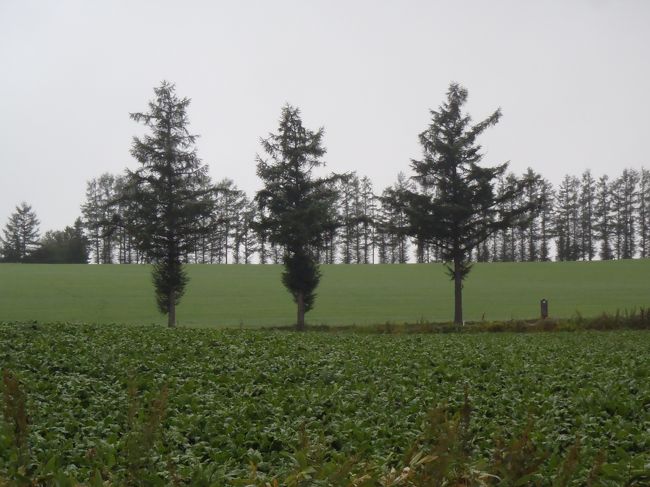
[{"left": 127, "top": 81, "right": 211, "bottom": 327}]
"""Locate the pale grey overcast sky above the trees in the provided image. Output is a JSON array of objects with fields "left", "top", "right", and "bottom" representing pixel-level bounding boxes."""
[{"left": 0, "top": 0, "right": 650, "bottom": 232}]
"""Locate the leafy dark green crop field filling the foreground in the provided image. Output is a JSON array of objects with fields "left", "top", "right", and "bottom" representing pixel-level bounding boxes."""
[{"left": 0, "top": 324, "right": 650, "bottom": 486}]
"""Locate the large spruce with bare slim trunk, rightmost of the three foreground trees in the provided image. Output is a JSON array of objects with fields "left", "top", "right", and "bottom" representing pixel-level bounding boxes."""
[{"left": 409, "top": 83, "right": 537, "bottom": 323}]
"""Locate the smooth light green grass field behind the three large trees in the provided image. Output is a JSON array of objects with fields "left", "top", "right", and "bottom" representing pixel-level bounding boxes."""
[{"left": 0, "top": 259, "right": 650, "bottom": 326}]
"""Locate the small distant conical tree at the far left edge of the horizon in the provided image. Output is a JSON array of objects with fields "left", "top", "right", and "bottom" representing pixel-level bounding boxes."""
[{"left": 0, "top": 201, "right": 40, "bottom": 262}]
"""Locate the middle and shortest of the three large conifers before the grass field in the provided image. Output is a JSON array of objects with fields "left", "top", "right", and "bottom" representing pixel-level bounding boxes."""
[{"left": 255, "top": 105, "right": 337, "bottom": 330}]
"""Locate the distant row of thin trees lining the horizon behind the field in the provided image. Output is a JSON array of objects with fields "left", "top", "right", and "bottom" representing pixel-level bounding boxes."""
[{"left": 0, "top": 169, "right": 650, "bottom": 264}]
